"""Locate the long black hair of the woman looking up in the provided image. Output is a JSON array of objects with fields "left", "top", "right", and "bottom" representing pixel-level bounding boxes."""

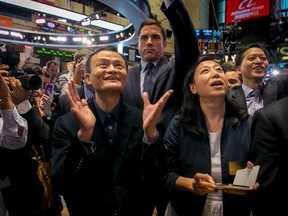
[{"left": 177, "top": 56, "right": 248, "bottom": 135}]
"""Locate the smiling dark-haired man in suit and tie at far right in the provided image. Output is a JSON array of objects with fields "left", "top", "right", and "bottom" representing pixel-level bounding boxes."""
[{"left": 229, "top": 43, "right": 288, "bottom": 115}]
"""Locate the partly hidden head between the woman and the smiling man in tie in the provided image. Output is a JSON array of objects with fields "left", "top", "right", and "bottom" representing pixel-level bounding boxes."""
[{"left": 223, "top": 62, "right": 242, "bottom": 87}]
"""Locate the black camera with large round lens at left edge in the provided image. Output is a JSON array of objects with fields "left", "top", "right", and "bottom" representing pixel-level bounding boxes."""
[{"left": 0, "top": 42, "right": 42, "bottom": 90}]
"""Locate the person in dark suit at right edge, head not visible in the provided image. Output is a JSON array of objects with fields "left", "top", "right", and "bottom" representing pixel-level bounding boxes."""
[{"left": 250, "top": 97, "right": 288, "bottom": 216}]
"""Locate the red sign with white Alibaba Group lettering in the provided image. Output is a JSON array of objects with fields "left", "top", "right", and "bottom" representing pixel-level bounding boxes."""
[{"left": 226, "top": 0, "right": 270, "bottom": 24}]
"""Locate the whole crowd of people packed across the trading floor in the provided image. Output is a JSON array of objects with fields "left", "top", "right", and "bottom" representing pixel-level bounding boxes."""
[{"left": 0, "top": 0, "right": 288, "bottom": 216}]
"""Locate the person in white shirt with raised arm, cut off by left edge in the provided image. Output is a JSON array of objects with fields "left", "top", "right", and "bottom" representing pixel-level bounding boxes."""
[{"left": 0, "top": 68, "right": 28, "bottom": 216}]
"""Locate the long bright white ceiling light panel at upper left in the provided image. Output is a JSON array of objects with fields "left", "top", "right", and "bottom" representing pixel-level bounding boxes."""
[{"left": 0, "top": 0, "right": 123, "bottom": 31}]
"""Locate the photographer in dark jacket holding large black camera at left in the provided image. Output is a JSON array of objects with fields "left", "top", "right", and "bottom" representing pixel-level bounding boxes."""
[{"left": 0, "top": 45, "right": 63, "bottom": 216}]
